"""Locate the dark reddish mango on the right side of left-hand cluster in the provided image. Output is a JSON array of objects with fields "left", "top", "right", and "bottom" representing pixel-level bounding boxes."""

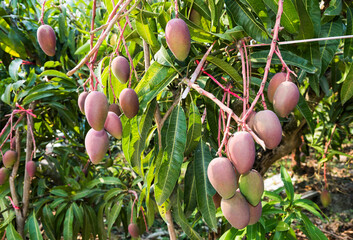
[{"left": 119, "top": 88, "right": 140, "bottom": 118}]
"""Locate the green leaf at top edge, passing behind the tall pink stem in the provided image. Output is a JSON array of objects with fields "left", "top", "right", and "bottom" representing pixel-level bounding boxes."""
[{"left": 263, "top": 0, "right": 300, "bottom": 34}]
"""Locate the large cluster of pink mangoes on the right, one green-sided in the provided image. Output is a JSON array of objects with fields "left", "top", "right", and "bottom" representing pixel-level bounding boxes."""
[{"left": 207, "top": 73, "right": 299, "bottom": 229}]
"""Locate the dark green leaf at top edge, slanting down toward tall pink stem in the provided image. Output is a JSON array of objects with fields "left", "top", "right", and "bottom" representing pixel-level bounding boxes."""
[{"left": 225, "top": 0, "right": 270, "bottom": 42}]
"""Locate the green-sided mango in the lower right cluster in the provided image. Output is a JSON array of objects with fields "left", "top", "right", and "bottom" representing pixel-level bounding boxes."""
[{"left": 239, "top": 169, "right": 264, "bottom": 206}]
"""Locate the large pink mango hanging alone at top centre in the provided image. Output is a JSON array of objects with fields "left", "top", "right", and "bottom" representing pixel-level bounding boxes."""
[{"left": 165, "top": 18, "right": 191, "bottom": 61}]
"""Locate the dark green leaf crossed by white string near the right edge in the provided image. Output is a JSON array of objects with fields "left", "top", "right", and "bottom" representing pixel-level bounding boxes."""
[{"left": 320, "top": 19, "right": 343, "bottom": 75}]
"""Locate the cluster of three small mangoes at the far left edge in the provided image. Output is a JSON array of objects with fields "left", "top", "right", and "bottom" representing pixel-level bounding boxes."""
[{"left": 0, "top": 150, "right": 37, "bottom": 185}]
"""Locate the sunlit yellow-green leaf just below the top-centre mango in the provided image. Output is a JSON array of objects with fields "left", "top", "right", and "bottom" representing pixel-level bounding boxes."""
[{"left": 135, "top": 62, "right": 176, "bottom": 109}]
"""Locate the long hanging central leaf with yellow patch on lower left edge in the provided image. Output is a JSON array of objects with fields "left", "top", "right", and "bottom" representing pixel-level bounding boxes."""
[{"left": 155, "top": 105, "right": 186, "bottom": 205}]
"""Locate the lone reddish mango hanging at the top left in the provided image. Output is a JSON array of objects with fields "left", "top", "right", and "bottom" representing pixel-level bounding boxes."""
[{"left": 37, "top": 25, "right": 56, "bottom": 57}]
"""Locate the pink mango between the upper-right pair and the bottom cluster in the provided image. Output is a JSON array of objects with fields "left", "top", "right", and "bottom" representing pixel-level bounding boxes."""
[{"left": 254, "top": 110, "right": 282, "bottom": 149}]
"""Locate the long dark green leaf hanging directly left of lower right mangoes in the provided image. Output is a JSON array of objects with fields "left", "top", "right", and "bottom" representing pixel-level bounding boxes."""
[{"left": 194, "top": 139, "right": 217, "bottom": 231}]
